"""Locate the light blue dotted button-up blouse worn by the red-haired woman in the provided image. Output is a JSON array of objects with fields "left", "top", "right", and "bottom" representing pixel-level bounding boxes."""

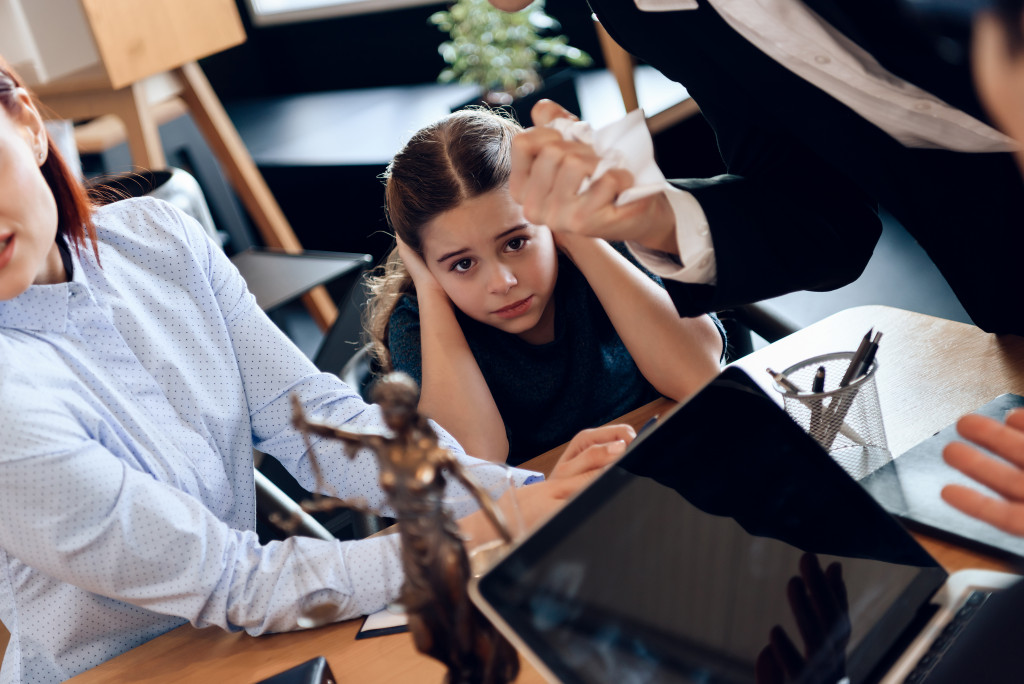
[{"left": 0, "top": 199, "right": 530, "bottom": 684}]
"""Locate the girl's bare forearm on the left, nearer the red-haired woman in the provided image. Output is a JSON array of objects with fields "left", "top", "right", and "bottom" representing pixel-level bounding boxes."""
[{"left": 398, "top": 241, "right": 509, "bottom": 463}]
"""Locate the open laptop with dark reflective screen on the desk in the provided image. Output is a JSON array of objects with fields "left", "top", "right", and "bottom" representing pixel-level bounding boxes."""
[{"left": 470, "top": 367, "right": 1020, "bottom": 684}]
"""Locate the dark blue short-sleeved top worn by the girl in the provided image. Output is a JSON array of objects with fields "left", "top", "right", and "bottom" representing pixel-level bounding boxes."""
[{"left": 388, "top": 245, "right": 725, "bottom": 465}]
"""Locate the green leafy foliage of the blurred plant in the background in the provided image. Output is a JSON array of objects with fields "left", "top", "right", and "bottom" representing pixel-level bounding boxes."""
[{"left": 430, "top": 0, "right": 593, "bottom": 114}]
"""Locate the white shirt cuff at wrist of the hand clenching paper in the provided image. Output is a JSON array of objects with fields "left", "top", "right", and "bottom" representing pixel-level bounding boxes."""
[{"left": 627, "top": 183, "right": 718, "bottom": 285}]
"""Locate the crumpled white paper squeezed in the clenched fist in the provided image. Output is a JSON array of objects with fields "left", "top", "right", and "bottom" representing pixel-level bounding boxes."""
[{"left": 547, "top": 110, "right": 667, "bottom": 207}]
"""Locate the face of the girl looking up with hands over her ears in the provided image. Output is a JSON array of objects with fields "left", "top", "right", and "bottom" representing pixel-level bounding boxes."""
[{"left": 421, "top": 187, "right": 558, "bottom": 344}]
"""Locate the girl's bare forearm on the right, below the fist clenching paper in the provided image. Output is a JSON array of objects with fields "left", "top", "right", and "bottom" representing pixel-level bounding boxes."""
[{"left": 555, "top": 233, "right": 722, "bottom": 401}]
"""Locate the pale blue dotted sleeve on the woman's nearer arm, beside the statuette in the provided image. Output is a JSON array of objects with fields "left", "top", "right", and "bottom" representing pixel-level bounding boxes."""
[{"left": 0, "top": 378, "right": 402, "bottom": 634}]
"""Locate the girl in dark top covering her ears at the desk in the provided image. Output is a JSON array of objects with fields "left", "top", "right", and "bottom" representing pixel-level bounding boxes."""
[{"left": 367, "top": 110, "right": 724, "bottom": 464}]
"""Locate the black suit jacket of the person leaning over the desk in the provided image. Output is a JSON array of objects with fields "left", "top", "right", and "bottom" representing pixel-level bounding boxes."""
[{"left": 590, "top": 0, "right": 1024, "bottom": 334}]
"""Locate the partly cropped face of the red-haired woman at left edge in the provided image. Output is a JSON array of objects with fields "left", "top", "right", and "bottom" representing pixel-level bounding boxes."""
[{"left": 0, "top": 90, "right": 67, "bottom": 301}]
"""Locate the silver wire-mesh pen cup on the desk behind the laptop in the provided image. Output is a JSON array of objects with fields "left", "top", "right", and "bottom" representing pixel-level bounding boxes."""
[{"left": 775, "top": 351, "right": 892, "bottom": 480}]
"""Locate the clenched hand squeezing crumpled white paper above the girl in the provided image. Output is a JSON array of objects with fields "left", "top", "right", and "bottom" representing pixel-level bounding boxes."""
[{"left": 509, "top": 99, "right": 678, "bottom": 252}]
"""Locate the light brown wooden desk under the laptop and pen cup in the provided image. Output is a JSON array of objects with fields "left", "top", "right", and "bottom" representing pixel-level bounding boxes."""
[{"left": 71, "top": 306, "right": 1024, "bottom": 684}]
